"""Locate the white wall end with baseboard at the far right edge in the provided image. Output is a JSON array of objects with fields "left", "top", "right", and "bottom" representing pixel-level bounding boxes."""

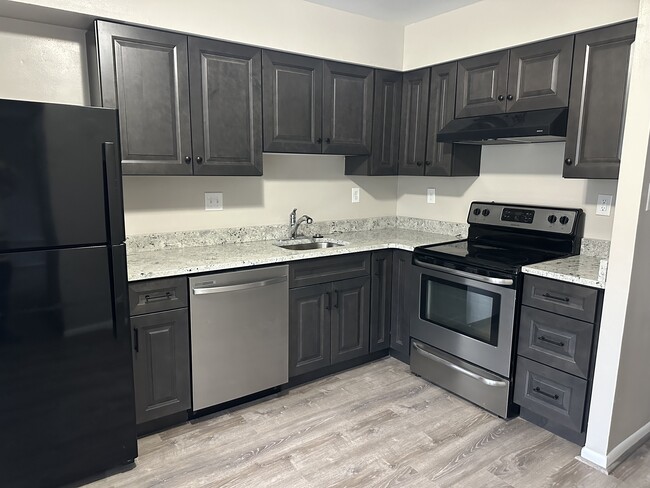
[{"left": 582, "top": 0, "right": 650, "bottom": 467}]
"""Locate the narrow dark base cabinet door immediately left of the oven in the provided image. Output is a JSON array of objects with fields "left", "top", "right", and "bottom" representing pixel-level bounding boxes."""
[{"left": 390, "top": 251, "right": 420, "bottom": 359}]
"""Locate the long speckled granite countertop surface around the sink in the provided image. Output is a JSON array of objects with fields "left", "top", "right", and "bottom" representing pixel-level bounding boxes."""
[{"left": 127, "top": 228, "right": 459, "bottom": 281}]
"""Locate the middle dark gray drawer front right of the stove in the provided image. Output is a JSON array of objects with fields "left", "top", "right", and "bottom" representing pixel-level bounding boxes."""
[{"left": 517, "top": 305, "right": 594, "bottom": 379}]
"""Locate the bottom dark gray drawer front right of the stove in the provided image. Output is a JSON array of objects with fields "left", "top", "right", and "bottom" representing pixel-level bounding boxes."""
[{"left": 514, "top": 356, "right": 587, "bottom": 432}]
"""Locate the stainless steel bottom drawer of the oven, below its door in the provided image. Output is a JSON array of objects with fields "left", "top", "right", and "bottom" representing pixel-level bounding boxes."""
[{"left": 411, "top": 340, "right": 510, "bottom": 418}]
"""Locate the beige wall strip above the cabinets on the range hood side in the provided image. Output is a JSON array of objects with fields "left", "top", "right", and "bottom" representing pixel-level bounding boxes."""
[{"left": 404, "top": 0, "right": 639, "bottom": 70}]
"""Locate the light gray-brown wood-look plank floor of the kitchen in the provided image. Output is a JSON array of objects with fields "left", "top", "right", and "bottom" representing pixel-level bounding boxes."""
[{"left": 86, "top": 358, "right": 650, "bottom": 488}]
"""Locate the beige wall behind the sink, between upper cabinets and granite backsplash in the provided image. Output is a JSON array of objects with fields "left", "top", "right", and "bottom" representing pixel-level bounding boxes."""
[{"left": 124, "top": 154, "right": 397, "bottom": 235}]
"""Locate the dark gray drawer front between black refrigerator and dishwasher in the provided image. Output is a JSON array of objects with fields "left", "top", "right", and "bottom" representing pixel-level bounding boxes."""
[{"left": 129, "top": 276, "right": 187, "bottom": 316}]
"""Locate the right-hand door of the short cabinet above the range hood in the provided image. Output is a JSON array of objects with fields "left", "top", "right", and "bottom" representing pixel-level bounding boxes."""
[{"left": 506, "top": 36, "right": 573, "bottom": 112}]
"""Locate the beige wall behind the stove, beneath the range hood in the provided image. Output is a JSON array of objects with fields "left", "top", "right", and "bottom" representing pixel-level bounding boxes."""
[{"left": 397, "top": 142, "right": 616, "bottom": 239}]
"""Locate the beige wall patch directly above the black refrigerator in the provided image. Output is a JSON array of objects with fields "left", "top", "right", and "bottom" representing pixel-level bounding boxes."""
[{"left": 0, "top": 17, "right": 89, "bottom": 105}]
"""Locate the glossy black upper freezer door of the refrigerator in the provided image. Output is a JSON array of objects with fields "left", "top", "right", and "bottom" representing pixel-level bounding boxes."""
[{"left": 0, "top": 100, "right": 124, "bottom": 253}]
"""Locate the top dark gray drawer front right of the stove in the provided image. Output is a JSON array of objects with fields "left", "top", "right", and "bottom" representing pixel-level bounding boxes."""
[{"left": 522, "top": 276, "right": 598, "bottom": 322}]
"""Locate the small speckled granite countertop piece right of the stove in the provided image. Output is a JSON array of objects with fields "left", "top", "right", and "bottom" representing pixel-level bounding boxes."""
[{"left": 522, "top": 254, "right": 607, "bottom": 289}]
